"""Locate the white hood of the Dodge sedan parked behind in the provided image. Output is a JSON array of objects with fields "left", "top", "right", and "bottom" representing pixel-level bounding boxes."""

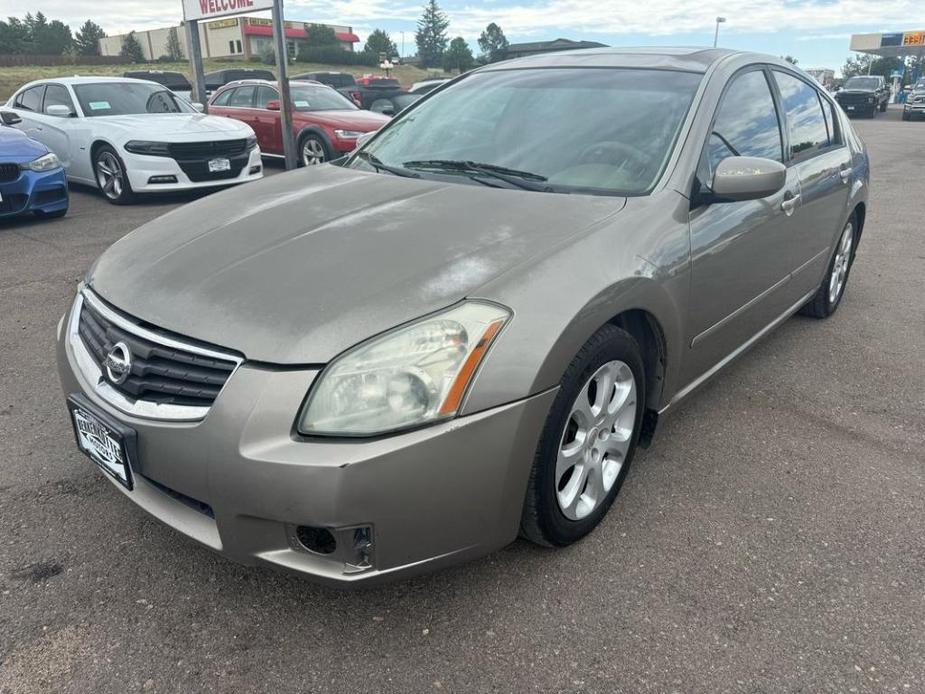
[{"left": 87, "top": 113, "right": 253, "bottom": 142}]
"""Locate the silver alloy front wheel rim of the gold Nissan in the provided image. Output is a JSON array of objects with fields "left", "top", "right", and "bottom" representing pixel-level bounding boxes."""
[{"left": 555, "top": 361, "right": 637, "bottom": 521}]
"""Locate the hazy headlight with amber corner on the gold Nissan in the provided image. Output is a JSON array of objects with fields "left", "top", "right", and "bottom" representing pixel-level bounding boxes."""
[{"left": 299, "top": 301, "right": 511, "bottom": 436}]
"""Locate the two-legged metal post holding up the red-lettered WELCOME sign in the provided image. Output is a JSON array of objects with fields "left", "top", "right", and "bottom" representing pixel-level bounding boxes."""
[{"left": 183, "top": 0, "right": 297, "bottom": 169}]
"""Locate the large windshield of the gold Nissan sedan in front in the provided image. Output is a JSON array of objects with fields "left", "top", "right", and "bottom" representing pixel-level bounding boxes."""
[{"left": 350, "top": 68, "right": 701, "bottom": 195}]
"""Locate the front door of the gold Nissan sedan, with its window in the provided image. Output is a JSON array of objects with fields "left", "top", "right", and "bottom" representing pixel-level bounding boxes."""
[{"left": 684, "top": 66, "right": 800, "bottom": 380}]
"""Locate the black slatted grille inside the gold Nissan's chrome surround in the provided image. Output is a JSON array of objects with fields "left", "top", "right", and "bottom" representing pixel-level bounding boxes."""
[{"left": 77, "top": 300, "right": 237, "bottom": 407}]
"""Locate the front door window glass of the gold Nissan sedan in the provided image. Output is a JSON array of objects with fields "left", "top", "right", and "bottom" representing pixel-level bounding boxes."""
[{"left": 707, "top": 70, "right": 783, "bottom": 174}]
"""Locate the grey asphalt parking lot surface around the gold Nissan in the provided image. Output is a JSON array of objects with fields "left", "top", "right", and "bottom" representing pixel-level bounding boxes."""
[{"left": 0, "top": 107, "right": 925, "bottom": 694}]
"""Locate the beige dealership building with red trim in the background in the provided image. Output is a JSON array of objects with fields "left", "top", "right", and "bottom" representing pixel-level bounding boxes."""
[{"left": 100, "top": 17, "right": 360, "bottom": 60}]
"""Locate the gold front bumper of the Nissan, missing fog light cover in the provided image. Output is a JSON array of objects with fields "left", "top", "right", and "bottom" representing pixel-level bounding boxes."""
[{"left": 58, "top": 300, "right": 555, "bottom": 584}]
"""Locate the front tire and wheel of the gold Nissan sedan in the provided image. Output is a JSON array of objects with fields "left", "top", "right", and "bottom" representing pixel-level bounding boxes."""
[{"left": 520, "top": 325, "right": 646, "bottom": 547}]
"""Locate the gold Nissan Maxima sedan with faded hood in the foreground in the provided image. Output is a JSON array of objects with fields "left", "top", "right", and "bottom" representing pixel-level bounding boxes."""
[{"left": 58, "top": 49, "right": 869, "bottom": 584}]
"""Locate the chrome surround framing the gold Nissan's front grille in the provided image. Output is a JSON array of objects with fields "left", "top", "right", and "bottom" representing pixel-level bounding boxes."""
[{"left": 68, "top": 287, "right": 244, "bottom": 422}]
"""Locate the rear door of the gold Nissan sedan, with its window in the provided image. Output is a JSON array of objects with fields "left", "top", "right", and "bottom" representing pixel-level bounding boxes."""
[{"left": 772, "top": 70, "right": 851, "bottom": 300}]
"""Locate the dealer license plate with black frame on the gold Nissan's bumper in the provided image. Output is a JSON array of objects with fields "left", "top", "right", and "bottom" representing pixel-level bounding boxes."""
[{"left": 67, "top": 393, "right": 138, "bottom": 491}]
